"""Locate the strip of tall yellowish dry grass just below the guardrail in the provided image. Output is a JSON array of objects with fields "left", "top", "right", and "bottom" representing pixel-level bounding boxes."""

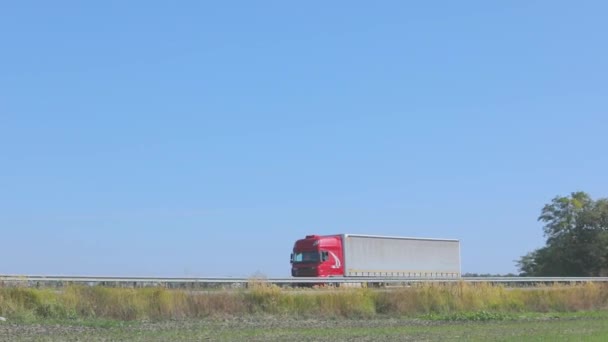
[{"left": 0, "top": 281, "right": 608, "bottom": 322}]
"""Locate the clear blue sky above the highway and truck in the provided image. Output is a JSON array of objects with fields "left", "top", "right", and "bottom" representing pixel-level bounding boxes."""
[{"left": 0, "top": 0, "right": 608, "bottom": 277}]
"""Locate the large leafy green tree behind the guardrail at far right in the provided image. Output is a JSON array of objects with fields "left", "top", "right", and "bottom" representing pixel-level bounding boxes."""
[{"left": 517, "top": 192, "right": 608, "bottom": 276}]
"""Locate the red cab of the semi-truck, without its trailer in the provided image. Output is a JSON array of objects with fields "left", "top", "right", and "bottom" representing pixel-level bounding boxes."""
[{"left": 291, "top": 235, "right": 344, "bottom": 277}]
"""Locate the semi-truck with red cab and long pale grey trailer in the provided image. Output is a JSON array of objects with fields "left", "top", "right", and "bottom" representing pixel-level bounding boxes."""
[{"left": 290, "top": 234, "right": 460, "bottom": 278}]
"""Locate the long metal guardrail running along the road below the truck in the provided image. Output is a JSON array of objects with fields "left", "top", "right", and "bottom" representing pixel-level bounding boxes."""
[{"left": 0, "top": 275, "right": 608, "bottom": 287}]
